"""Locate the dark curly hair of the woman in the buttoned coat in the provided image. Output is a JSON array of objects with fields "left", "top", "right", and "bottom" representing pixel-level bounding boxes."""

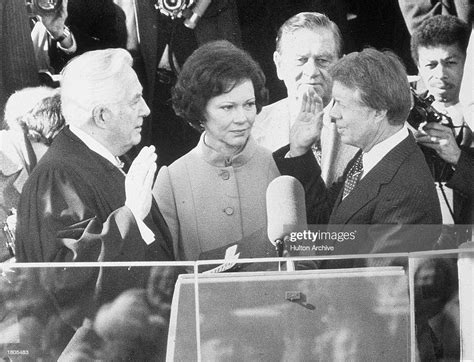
[{"left": 172, "top": 40, "right": 268, "bottom": 130}]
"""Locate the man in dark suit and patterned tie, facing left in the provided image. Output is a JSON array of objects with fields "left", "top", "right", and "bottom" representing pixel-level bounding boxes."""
[{"left": 288, "top": 49, "right": 441, "bottom": 267}]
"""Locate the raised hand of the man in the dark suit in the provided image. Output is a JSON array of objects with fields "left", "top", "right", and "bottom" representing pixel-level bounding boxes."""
[{"left": 290, "top": 87, "right": 323, "bottom": 157}]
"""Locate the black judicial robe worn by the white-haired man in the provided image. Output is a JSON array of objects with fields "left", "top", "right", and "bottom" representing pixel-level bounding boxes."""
[{"left": 16, "top": 127, "right": 174, "bottom": 327}]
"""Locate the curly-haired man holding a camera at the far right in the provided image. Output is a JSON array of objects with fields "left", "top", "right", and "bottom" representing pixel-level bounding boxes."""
[{"left": 408, "top": 15, "right": 473, "bottom": 229}]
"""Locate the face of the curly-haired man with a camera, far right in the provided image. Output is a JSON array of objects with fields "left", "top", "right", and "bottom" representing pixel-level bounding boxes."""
[{"left": 418, "top": 44, "right": 466, "bottom": 106}]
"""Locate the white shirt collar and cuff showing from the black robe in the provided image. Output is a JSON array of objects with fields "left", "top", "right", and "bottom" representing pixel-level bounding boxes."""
[{"left": 69, "top": 125, "right": 155, "bottom": 245}]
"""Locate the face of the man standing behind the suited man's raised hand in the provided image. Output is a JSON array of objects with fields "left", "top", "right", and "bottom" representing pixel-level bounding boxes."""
[{"left": 273, "top": 28, "right": 338, "bottom": 105}]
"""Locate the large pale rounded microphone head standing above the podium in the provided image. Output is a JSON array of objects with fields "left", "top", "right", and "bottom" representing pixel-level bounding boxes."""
[{"left": 266, "top": 176, "right": 307, "bottom": 245}]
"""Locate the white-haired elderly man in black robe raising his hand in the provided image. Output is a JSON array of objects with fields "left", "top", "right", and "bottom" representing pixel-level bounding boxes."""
[{"left": 16, "top": 49, "right": 174, "bottom": 327}]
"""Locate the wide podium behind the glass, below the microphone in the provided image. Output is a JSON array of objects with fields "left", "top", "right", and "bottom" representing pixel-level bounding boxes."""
[{"left": 167, "top": 267, "right": 411, "bottom": 362}]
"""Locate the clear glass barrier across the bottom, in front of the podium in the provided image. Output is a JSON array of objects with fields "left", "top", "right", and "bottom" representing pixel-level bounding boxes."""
[{"left": 0, "top": 246, "right": 474, "bottom": 361}]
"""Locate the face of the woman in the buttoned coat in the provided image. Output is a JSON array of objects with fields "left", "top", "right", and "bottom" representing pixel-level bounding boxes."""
[{"left": 203, "top": 79, "right": 257, "bottom": 155}]
